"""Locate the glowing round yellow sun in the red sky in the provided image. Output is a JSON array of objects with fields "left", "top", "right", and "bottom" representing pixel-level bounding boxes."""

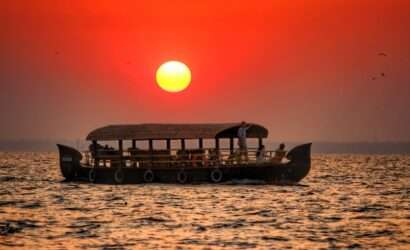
[{"left": 156, "top": 61, "right": 191, "bottom": 93}]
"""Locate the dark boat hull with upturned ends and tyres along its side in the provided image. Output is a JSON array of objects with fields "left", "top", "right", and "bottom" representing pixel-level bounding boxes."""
[{"left": 55, "top": 144, "right": 311, "bottom": 184}]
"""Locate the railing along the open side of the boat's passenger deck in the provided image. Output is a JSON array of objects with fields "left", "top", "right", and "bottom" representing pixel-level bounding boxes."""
[{"left": 83, "top": 148, "right": 286, "bottom": 167}]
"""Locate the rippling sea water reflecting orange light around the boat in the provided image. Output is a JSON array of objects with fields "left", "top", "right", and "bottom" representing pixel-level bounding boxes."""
[{"left": 0, "top": 153, "right": 410, "bottom": 249}]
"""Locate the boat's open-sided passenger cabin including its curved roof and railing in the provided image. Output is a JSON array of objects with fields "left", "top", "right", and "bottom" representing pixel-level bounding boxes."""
[{"left": 85, "top": 123, "right": 272, "bottom": 168}]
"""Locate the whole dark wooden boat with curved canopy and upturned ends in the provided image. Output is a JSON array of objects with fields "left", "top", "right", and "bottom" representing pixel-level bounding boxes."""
[{"left": 57, "top": 123, "right": 311, "bottom": 184}]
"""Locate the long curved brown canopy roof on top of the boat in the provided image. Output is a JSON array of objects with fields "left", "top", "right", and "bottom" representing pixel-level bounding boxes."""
[{"left": 87, "top": 123, "right": 268, "bottom": 141}]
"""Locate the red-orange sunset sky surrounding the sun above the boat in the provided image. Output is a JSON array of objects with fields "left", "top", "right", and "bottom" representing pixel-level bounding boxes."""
[{"left": 0, "top": 0, "right": 410, "bottom": 141}]
